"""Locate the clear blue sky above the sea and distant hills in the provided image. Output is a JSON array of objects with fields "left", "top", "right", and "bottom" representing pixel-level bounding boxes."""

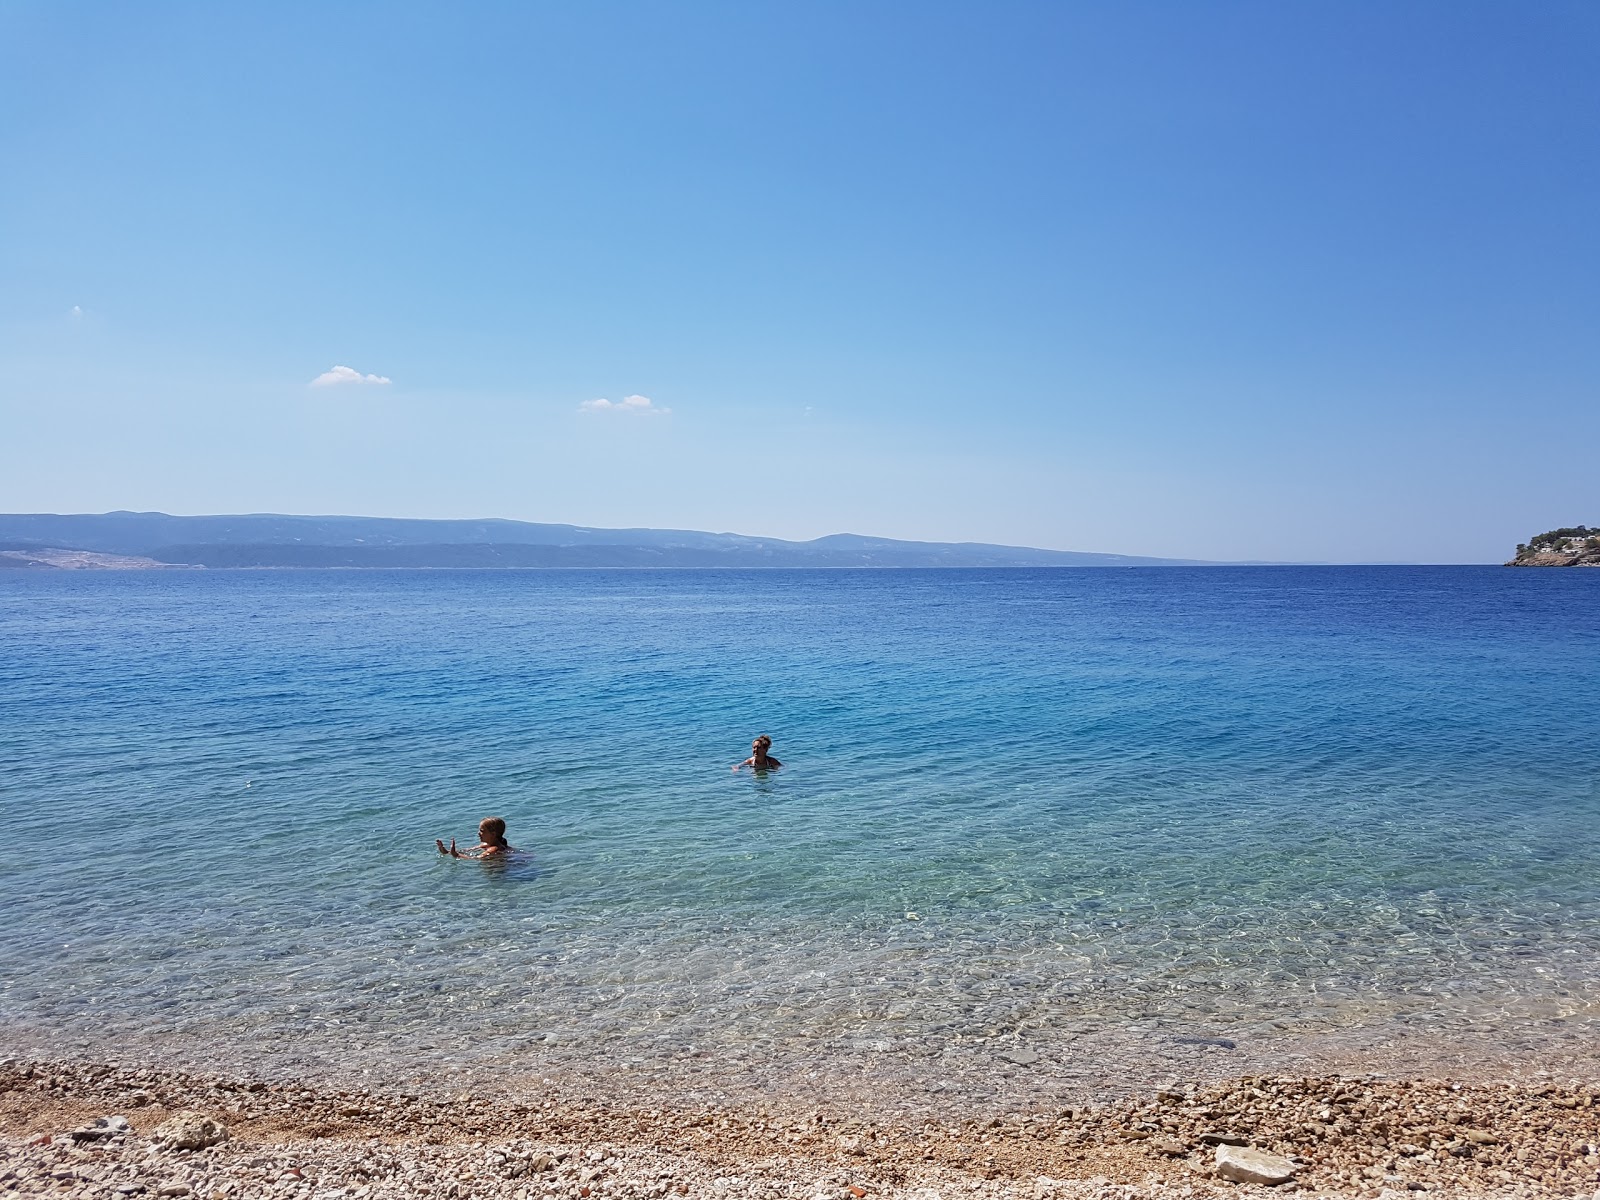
[{"left": 0, "top": 0, "right": 1600, "bottom": 562}]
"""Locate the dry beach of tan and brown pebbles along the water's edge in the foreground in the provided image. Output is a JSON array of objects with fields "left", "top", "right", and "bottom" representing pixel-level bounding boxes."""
[{"left": 0, "top": 1061, "right": 1600, "bottom": 1200}]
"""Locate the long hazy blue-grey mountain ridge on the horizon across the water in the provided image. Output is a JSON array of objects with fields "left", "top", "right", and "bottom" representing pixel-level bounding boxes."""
[{"left": 0, "top": 512, "right": 1202, "bottom": 570}]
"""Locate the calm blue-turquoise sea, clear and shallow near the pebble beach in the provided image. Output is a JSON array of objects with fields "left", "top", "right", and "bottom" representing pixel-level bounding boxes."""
[{"left": 0, "top": 566, "right": 1600, "bottom": 1107}]
